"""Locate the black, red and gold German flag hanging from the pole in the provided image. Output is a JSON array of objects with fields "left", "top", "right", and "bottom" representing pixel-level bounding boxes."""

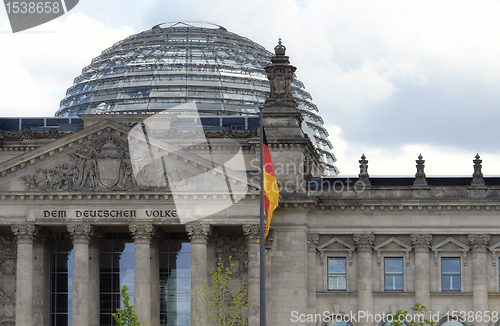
[{"left": 262, "top": 132, "right": 279, "bottom": 239}]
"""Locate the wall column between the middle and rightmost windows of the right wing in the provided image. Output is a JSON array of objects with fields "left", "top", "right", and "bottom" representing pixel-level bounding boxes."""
[{"left": 410, "top": 234, "right": 432, "bottom": 310}]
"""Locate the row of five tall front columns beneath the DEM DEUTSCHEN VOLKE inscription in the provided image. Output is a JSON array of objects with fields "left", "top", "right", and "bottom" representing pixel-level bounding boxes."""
[{"left": 11, "top": 223, "right": 260, "bottom": 326}]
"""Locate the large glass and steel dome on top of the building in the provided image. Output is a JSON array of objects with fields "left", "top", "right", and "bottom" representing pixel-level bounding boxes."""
[{"left": 56, "top": 21, "right": 338, "bottom": 175}]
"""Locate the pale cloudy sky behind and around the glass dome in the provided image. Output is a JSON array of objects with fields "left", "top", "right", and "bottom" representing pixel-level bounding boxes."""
[{"left": 0, "top": 0, "right": 500, "bottom": 176}]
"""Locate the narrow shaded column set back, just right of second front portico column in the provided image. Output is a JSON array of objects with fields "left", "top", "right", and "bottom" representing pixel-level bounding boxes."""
[{"left": 89, "top": 229, "right": 104, "bottom": 326}]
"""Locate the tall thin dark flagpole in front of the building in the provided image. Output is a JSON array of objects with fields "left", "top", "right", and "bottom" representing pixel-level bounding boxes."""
[{"left": 259, "top": 107, "right": 266, "bottom": 326}]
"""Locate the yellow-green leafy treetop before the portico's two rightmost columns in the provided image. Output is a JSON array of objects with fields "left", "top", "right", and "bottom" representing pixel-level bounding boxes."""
[{"left": 191, "top": 256, "right": 248, "bottom": 326}]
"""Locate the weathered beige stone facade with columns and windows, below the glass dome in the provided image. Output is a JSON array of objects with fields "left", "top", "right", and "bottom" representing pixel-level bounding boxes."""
[{"left": 0, "top": 44, "right": 500, "bottom": 326}]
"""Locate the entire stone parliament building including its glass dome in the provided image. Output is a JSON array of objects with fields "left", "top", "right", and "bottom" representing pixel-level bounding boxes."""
[{"left": 0, "top": 21, "right": 500, "bottom": 326}]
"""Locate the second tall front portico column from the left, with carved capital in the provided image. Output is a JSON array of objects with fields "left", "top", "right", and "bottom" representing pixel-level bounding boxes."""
[{"left": 68, "top": 224, "right": 94, "bottom": 326}]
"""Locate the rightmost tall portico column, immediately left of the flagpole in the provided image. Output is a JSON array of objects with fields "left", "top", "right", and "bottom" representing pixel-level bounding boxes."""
[{"left": 243, "top": 224, "right": 260, "bottom": 326}]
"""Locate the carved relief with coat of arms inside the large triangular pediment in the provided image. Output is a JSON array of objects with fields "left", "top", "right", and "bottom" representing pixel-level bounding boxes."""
[{"left": 20, "top": 135, "right": 136, "bottom": 191}]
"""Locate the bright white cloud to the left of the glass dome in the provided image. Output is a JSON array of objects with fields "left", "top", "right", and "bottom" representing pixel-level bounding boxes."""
[{"left": 0, "top": 13, "right": 133, "bottom": 116}]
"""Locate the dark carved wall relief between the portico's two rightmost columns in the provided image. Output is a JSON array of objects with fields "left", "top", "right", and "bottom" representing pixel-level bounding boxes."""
[{"left": 215, "top": 235, "right": 248, "bottom": 275}]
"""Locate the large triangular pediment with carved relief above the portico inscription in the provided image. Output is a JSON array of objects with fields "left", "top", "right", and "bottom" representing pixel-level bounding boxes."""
[{"left": 0, "top": 119, "right": 252, "bottom": 194}]
